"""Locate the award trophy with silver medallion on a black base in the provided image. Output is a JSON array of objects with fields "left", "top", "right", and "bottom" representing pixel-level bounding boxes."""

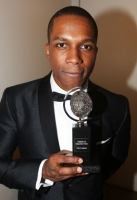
[{"left": 63, "top": 87, "right": 100, "bottom": 173}]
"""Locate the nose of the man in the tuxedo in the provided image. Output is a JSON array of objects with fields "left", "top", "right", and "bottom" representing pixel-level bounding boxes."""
[{"left": 66, "top": 48, "right": 83, "bottom": 65}]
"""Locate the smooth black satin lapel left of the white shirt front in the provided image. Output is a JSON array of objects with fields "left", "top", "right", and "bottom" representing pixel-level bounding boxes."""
[{"left": 38, "top": 74, "right": 60, "bottom": 154}]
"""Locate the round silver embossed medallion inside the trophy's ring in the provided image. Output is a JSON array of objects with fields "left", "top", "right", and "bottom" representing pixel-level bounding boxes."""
[{"left": 70, "top": 90, "right": 93, "bottom": 119}]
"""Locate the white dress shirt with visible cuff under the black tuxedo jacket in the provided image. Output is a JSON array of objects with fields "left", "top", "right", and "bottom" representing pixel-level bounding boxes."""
[{"left": 36, "top": 74, "right": 88, "bottom": 190}]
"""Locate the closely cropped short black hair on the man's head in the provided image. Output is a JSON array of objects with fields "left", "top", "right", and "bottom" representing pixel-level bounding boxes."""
[{"left": 47, "top": 6, "right": 98, "bottom": 42}]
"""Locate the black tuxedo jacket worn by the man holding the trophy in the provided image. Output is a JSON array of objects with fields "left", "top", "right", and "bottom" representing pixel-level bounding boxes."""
[{"left": 0, "top": 74, "right": 130, "bottom": 200}]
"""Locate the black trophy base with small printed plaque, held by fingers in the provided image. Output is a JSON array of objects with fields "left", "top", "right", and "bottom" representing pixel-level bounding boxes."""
[{"left": 72, "top": 126, "right": 100, "bottom": 173}]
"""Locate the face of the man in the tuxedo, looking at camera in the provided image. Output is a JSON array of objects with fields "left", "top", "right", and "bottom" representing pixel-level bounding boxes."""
[{"left": 46, "top": 15, "right": 97, "bottom": 91}]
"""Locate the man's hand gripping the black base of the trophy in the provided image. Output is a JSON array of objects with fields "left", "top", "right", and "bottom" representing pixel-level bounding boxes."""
[{"left": 42, "top": 150, "right": 87, "bottom": 182}]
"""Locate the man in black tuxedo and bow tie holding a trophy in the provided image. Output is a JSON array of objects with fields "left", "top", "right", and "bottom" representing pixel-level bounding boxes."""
[{"left": 0, "top": 6, "right": 130, "bottom": 200}]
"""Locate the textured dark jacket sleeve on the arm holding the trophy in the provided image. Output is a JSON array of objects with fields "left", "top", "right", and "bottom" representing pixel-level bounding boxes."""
[{"left": 0, "top": 90, "right": 41, "bottom": 189}]
